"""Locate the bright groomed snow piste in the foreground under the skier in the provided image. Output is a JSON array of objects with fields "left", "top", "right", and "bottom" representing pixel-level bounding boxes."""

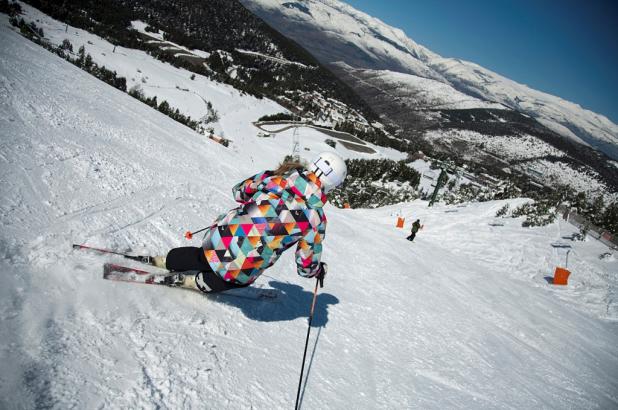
[{"left": 0, "top": 15, "right": 618, "bottom": 409}]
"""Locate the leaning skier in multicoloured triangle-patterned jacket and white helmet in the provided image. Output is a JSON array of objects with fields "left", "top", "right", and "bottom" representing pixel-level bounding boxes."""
[{"left": 154, "top": 152, "right": 347, "bottom": 293}]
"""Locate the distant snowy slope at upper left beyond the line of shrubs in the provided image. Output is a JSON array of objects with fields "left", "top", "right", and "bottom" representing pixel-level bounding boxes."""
[{"left": 16, "top": 4, "right": 287, "bottom": 142}]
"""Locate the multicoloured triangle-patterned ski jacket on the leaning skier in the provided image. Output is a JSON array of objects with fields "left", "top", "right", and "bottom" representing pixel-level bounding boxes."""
[{"left": 202, "top": 168, "right": 326, "bottom": 284}]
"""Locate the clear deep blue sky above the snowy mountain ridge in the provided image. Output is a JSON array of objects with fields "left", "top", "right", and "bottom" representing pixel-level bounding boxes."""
[{"left": 343, "top": 0, "right": 618, "bottom": 124}]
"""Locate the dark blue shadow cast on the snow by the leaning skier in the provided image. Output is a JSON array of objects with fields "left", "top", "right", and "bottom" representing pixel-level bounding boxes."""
[{"left": 213, "top": 281, "right": 339, "bottom": 327}]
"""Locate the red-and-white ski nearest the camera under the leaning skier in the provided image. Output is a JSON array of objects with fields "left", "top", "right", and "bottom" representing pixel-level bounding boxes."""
[{"left": 103, "top": 263, "right": 277, "bottom": 300}]
